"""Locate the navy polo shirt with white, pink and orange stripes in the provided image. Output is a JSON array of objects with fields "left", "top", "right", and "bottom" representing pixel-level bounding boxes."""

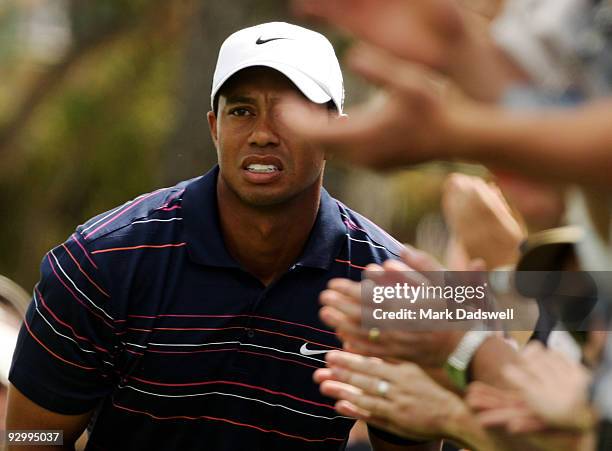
[{"left": 10, "top": 167, "right": 401, "bottom": 451}]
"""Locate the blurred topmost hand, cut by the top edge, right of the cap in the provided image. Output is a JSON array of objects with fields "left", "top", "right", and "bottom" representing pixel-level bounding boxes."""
[{"left": 293, "top": 0, "right": 525, "bottom": 101}]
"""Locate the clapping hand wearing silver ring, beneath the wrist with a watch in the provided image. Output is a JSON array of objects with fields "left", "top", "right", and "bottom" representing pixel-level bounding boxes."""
[{"left": 314, "top": 351, "right": 469, "bottom": 438}]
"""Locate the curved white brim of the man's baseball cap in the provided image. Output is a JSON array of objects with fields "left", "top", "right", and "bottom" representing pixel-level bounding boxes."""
[{"left": 210, "top": 60, "right": 334, "bottom": 111}]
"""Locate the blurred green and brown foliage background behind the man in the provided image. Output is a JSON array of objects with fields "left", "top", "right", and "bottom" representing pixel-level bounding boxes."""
[{"left": 0, "top": 0, "right": 498, "bottom": 291}]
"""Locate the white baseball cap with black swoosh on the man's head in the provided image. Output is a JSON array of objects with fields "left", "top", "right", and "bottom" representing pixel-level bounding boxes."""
[{"left": 210, "top": 22, "right": 344, "bottom": 113}]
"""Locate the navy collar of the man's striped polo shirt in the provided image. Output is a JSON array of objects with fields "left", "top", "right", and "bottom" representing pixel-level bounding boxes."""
[{"left": 182, "top": 165, "right": 347, "bottom": 269}]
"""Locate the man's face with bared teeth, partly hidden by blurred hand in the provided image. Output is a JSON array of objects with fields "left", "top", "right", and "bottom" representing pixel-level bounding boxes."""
[{"left": 208, "top": 68, "right": 329, "bottom": 207}]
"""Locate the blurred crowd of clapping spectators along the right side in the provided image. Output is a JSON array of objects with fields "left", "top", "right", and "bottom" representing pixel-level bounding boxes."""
[{"left": 285, "top": 0, "right": 612, "bottom": 450}]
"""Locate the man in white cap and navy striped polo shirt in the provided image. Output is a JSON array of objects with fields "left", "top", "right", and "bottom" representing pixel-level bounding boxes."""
[{"left": 7, "top": 23, "right": 430, "bottom": 451}]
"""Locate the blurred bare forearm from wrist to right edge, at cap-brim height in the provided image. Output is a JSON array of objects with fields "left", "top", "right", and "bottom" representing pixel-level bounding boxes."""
[{"left": 449, "top": 99, "right": 612, "bottom": 188}]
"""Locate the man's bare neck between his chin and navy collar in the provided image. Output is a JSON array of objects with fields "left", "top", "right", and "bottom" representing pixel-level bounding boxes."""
[{"left": 217, "top": 182, "right": 321, "bottom": 285}]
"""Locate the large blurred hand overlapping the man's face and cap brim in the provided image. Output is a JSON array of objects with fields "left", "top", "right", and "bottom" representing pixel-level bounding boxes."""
[{"left": 281, "top": 46, "right": 465, "bottom": 169}]
